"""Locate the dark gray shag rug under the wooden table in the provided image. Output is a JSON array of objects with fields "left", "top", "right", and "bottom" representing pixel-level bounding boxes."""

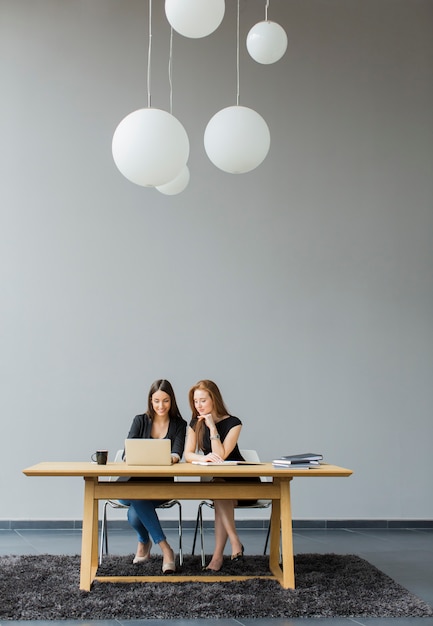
[{"left": 0, "top": 554, "right": 433, "bottom": 620}]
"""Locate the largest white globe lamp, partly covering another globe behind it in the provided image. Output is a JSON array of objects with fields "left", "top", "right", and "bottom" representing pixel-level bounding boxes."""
[{"left": 112, "top": 108, "right": 189, "bottom": 187}]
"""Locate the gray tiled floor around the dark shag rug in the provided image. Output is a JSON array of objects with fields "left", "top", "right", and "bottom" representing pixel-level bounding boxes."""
[{"left": 0, "top": 529, "right": 433, "bottom": 626}]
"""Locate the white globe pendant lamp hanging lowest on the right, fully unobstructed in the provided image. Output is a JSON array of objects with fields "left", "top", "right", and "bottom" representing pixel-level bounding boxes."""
[{"left": 204, "top": 105, "right": 271, "bottom": 174}]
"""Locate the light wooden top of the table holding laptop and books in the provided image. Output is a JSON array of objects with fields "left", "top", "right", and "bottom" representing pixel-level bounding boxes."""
[{"left": 23, "top": 461, "right": 353, "bottom": 479}]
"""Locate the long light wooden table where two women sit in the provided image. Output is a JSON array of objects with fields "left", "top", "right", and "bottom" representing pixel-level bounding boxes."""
[{"left": 23, "top": 462, "right": 352, "bottom": 591}]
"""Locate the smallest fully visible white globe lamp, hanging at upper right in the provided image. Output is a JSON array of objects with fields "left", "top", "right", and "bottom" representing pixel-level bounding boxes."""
[{"left": 247, "top": 21, "right": 287, "bottom": 65}]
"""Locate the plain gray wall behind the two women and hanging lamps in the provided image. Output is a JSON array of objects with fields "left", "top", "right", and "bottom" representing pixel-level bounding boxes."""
[{"left": 0, "top": 0, "right": 433, "bottom": 520}]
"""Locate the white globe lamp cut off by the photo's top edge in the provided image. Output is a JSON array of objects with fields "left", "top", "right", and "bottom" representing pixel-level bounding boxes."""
[{"left": 165, "top": 0, "right": 225, "bottom": 39}]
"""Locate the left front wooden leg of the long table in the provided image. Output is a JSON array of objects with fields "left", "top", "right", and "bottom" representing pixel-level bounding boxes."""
[{"left": 80, "top": 478, "right": 98, "bottom": 591}]
